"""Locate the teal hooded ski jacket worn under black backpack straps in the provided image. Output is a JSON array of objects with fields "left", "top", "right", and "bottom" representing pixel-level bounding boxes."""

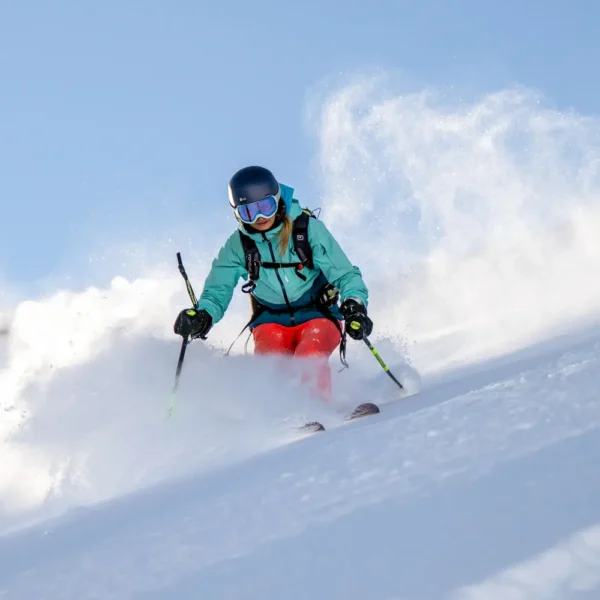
[{"left": 197, "top": 184, "right": 368, "bottom": 328}]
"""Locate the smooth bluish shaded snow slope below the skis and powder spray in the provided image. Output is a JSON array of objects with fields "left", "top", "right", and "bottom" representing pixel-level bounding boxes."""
[{"left": 0, "top": 341, "right": 600, "bottom": 600}]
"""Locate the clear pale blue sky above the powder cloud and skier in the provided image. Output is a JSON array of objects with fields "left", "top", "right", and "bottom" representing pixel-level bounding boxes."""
[{"left": 0, "top": 0, "right": 600, "bottom": 285}]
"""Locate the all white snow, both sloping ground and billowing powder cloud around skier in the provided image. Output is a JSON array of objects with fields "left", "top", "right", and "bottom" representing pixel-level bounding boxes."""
[{"left": 0, "top": 80, "right": 600, "bottom": 600}]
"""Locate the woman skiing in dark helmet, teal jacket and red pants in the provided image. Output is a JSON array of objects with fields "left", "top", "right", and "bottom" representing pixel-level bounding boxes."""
[{"left": 174, "top": 166, "right": 373, "bottom": 400}]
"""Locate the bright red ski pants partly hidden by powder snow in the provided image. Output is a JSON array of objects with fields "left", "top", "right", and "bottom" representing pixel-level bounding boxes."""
[{"left": 252, "top": 318, "right": 341, "bottom": 400}]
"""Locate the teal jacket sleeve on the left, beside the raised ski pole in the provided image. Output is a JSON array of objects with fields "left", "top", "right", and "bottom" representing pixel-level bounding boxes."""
[{"left": 197, "top": 231, "right": 247, "bottom": 324}]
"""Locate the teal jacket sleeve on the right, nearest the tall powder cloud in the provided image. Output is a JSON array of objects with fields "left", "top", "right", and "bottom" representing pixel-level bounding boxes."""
[{"left": 308, "top": 219, "right": 369, "bottom": 306}]
